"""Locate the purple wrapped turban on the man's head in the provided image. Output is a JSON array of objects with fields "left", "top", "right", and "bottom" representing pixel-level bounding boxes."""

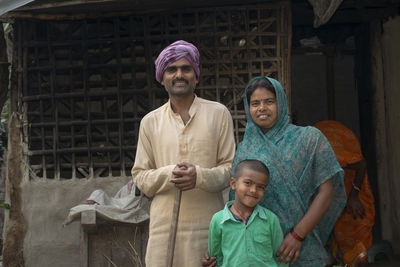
[{"left": 154, "top": 40, "right": 200, "bottom": 83}]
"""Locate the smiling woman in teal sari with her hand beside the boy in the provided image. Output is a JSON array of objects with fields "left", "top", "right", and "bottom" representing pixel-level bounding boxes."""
[{"left": 202, "top": 77, "right": 346, "bottom": 267}]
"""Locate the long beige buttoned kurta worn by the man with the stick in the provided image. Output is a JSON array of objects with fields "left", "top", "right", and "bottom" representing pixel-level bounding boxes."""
[{"left": 132, "top": 97, "right": 235, "bottom": 267}]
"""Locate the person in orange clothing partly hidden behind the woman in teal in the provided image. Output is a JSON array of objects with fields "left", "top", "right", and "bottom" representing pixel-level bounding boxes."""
[{"left": 315, "top": 121, "right": 375, "bottom": 267}]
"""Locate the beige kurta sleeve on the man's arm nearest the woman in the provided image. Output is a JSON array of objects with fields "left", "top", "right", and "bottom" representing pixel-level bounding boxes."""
[{"left": 196, "top": 109, "right": 235, "bottom": 192}]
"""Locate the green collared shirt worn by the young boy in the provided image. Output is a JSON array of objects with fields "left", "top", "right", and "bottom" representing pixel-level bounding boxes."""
[{"left": 208, "top": 201, "right": 289, "bottom": 267}]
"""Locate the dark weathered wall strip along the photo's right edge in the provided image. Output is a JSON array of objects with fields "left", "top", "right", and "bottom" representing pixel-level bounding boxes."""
[{"left": 371, "top": 16, "right": 400, "bottom": 255}]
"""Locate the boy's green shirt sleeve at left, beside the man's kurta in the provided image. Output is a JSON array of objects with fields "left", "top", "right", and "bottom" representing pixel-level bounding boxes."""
[{"left": 208, "top": 214, "right": 223, "bottom": 266}]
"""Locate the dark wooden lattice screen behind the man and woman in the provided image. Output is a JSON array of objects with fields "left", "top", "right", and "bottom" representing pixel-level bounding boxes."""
[{"left": 14, "top": 4, "right": 291, "bottom": 179}]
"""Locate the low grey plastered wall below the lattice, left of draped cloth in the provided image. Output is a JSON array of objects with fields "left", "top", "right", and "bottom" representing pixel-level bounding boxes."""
[{"left": 21, "top": 178, "right": 127, "bottom": 267}]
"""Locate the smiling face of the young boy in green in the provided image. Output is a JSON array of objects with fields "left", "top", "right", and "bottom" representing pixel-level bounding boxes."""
[{"left": 230, "top": 167, "right": 268, "bottom": 209}]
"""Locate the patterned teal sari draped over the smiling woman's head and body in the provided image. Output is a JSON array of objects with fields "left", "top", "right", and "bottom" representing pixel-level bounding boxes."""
[{"left": 230, "top": 77, "right": 346, "bottom": 266}]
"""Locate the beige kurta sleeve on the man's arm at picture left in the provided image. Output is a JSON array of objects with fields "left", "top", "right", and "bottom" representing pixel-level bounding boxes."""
[{"left": 132, "top": 121, "right": 175, "bottom": 197}]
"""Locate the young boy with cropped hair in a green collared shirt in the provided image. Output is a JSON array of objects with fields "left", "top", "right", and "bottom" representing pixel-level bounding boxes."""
[{"left": 208, "top": 159, "right": 288, "bottom": 267}]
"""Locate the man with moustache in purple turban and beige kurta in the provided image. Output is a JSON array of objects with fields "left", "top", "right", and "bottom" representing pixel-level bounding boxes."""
[{"left": 132, "top": 40, "right": 235, "bottom": 267}]
